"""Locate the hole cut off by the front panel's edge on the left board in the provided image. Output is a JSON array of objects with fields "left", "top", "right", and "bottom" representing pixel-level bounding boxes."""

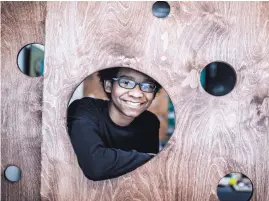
[{"left": 17, "top": 43, "right": 44, "bottom": 77}]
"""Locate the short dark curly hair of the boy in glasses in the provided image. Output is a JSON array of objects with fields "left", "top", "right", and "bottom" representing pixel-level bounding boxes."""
[{"left": 97, "top": 67, "right": 162, "bottom": 99}]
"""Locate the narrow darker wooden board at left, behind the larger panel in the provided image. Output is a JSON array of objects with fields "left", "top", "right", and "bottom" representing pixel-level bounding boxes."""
[{"left": 1, "top": 2, "right": 46, "bottom": 201}]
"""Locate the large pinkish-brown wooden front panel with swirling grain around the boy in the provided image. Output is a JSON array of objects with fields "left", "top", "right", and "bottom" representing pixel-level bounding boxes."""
[{"left": 41, "top": 2, "right": 269, "bottom": 201}]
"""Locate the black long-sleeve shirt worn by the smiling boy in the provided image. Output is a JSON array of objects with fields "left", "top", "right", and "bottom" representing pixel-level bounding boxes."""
[{"left": 67, "top": 97, "right": 160, "bottom": 181}]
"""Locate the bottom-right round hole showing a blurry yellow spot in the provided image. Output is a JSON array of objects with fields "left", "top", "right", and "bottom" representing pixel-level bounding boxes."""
[{"left": 217, "top": 172, "right": 253, "bottom": 201}]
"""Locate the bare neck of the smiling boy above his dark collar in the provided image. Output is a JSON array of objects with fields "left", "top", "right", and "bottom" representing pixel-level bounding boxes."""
[{"left": 108, "top": 102, "right": 134, "bottom": 126}]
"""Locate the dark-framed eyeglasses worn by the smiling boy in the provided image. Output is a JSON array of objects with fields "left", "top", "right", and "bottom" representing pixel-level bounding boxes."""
[{"left": 112, "top": 77, "right": 156, "bottom": 93}]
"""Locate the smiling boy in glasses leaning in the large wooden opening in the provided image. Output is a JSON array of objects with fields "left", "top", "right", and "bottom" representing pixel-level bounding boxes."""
[{"left": 67, "top": 67, "right": 161, "bottom": 181}]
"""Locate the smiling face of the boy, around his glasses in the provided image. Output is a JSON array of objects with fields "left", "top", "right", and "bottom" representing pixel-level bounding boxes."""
[{"left": 105, "top": 68, "right": 154, "bottom": 118}]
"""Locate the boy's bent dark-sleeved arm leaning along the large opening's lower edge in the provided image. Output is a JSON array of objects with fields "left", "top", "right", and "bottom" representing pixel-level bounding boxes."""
[{"left": 68, "top": 99, "right": 153, "bottom": 181}]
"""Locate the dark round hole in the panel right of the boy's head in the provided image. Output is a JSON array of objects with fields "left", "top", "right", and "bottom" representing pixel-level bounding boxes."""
[{"left": 200, "top": 62, "right": 236, "bottom": 96}]
